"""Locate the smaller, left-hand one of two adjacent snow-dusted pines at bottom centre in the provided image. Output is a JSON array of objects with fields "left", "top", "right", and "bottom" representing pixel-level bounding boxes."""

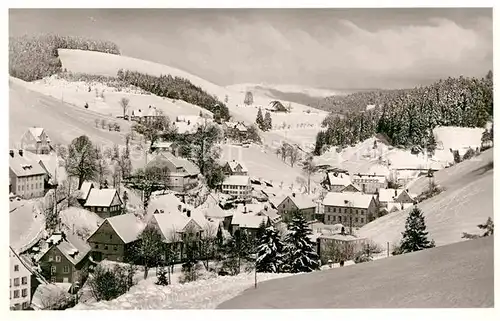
[{"left": 256, "top": 226, "right": 283, "bottom": 273}]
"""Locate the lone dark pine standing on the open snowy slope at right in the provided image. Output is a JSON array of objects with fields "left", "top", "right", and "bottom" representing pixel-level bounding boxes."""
[{"left": 400, "top": 207, "right": 435, "bottom": 254}]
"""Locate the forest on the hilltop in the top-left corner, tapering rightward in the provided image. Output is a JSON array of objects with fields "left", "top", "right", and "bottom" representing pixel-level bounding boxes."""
[{"left": 9, "top": 34, "right": 120, "bottom": 81}]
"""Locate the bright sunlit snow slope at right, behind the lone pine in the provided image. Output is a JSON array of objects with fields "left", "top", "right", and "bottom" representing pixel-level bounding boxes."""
[{"left": 359, "top": 150, "right": 493, "bottom": 247}]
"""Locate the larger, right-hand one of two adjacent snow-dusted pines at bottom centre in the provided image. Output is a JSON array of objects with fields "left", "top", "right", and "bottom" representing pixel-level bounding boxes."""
[{"left": 284, "top": 212, "right": 319, "bottom": 273}]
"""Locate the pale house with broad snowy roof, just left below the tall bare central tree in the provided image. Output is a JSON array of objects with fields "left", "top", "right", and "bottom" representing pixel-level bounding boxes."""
[{"left": 146, "top": 152, "right": 200, "bottom": 192}]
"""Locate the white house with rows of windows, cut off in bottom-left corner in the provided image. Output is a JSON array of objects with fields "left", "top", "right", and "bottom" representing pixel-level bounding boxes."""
[{"left": 9, "top": 247, "right": 32, "bottom": 310}]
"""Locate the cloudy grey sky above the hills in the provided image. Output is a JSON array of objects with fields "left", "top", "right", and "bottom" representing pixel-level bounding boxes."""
[{"left": 9, "top": 9, "right": 493, "bottom": 89}]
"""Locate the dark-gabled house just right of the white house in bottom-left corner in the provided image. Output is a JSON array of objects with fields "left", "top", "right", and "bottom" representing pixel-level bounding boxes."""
[{"left": 37, "top": 233, "right": 90, "bottom": 284}]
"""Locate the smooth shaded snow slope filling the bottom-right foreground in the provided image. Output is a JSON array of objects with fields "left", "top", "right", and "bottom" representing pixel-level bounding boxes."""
[{"left": 218, "top": 237, "right": 494, "bottom": 309}]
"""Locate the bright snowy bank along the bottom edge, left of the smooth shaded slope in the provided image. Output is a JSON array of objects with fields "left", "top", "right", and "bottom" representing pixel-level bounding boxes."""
[{"left": 73, "top": 273, "right": 291, "bottom": 310}]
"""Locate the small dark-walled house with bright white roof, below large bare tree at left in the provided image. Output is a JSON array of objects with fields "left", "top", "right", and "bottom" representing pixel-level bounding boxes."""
[{"left": 82, "top": 188, "right": 123, "bottom": 218}]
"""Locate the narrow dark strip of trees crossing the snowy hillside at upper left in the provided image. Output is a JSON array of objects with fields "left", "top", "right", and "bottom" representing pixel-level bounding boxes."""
[{"left": 117, "top": 69, "right": 229, "bottom": 120}]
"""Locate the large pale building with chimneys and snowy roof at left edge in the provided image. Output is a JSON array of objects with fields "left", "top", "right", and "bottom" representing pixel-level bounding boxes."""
[{"left": 9, "top": 149, "right": 47, "bottom": 199}]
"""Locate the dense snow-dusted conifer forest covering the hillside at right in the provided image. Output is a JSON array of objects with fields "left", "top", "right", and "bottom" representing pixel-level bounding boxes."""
[{"left": 314, "top": 71, "right": 493, "bottom": 155}]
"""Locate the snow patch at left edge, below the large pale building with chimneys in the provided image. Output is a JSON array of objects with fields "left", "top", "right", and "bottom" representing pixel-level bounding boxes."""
[{"left": 9, "top": 200, "right": 45, "bottom": 253}]
